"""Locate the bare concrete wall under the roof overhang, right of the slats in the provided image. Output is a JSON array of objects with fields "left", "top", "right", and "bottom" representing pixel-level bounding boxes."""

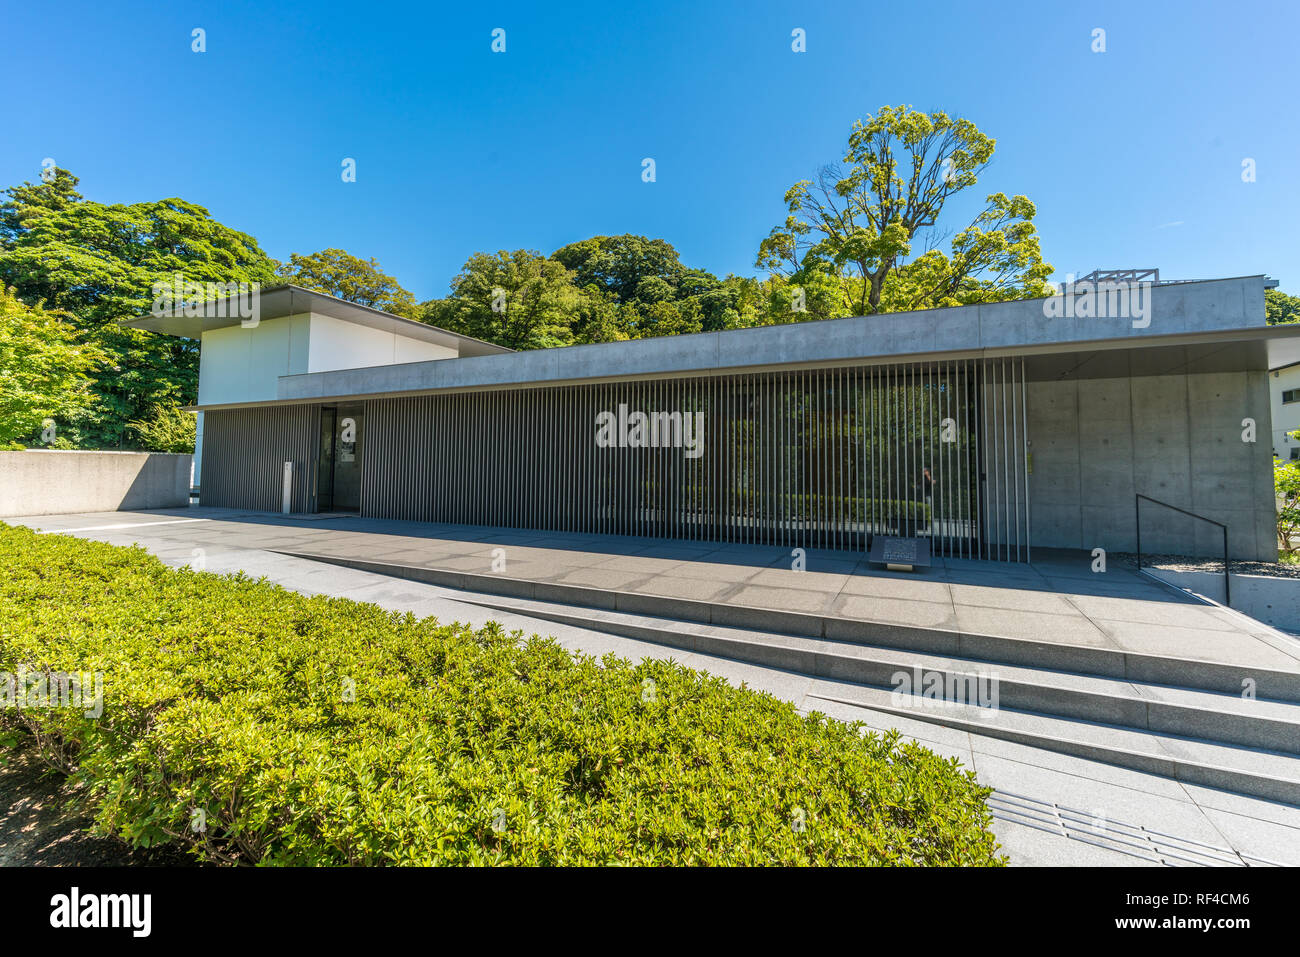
[{"left": 1028, "top": 369, "right": 1277, "bottom": 560}]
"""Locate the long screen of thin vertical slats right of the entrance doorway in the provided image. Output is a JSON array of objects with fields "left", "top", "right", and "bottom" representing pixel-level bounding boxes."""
[{"left": 361, "top": 359, "right": 1030, "bottom": 560}]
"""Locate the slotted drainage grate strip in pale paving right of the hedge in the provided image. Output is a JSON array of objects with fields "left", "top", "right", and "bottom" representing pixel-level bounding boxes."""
[{"left": 988, "top": 791, "right": 1283, "bottom": 867}]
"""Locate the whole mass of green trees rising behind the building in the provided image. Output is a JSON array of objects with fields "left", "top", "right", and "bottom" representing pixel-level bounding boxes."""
[{"left": 0, "top": 107, "right": 1066, "bottom": 450}]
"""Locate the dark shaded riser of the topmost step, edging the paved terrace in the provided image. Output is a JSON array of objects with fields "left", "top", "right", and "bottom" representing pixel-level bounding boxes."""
[{"left": 278, "top": 550, "right": 1300, "bottom": 703}]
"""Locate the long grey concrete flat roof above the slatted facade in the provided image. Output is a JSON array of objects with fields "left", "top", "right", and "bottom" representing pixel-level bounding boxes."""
[{"left": 126, "top": 276, "right": 1300, "bottom": 410}]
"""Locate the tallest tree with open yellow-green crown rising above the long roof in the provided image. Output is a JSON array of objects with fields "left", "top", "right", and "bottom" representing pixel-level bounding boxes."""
[{"left": 757, "top": 107, "right": 1052, "bottom": 317}]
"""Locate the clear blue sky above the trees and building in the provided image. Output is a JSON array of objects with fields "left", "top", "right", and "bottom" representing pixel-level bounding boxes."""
[{"left": 0, "top": 0, "right": 1300, "bottom": 299}]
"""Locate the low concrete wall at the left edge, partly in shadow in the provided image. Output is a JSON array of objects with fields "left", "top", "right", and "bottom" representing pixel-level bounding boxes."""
[{"left": 0, "top": 449, "right": 192, "bottom": 516}]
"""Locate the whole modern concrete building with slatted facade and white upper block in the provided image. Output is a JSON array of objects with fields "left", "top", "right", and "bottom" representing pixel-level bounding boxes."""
[{"left": 127, "top": 276, "right": 1300, "bottom": 560}]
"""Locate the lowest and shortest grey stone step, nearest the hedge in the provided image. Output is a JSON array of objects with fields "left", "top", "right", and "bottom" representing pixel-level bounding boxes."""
[{"left": 810, "top": 683, "right": 1300, "bottom": 806}]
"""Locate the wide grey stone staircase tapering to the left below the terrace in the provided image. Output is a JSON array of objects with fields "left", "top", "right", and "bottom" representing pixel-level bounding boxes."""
[{"left": 276, "top": 551, "right": 1300, "bottom": 806}]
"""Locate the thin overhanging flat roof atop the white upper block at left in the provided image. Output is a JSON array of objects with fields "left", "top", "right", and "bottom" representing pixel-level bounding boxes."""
[{"left": 118, "top": 283, "right": 515, "bottom": 356}]
